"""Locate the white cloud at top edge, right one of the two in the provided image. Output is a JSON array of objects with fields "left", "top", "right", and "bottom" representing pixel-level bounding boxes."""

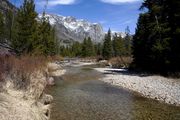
[{"left": 100, "top": 0, "right": 142, "bottom": 4}]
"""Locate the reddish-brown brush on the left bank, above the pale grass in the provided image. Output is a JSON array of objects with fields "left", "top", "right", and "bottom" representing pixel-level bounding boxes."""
[{"left": 0, "top": 56, "right": 47, "bottom": 89}]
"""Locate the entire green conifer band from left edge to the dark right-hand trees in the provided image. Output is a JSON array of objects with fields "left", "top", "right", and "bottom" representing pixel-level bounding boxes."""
[{"left": 0, "top": 0, "right": 131, "bottom": 59}]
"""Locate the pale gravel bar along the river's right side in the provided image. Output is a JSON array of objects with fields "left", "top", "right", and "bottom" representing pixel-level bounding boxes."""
[{"left": 96, "top": 68, "right": 180, "bottom": 106}]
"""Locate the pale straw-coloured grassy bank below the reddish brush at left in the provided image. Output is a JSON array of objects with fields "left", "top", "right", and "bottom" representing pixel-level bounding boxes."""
[{"left": 0, "top": 63, "right": 64, "bottom": 120}]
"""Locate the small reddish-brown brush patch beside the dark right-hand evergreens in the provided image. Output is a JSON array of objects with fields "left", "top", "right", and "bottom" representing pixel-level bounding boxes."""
[{"left": 109, "top": 57, "right": 133, "bottom": 68}]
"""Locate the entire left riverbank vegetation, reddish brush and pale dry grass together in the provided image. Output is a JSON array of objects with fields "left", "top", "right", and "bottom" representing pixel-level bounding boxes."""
[{"left": 0, "top": 56, "right": 65, "bottom": 120}]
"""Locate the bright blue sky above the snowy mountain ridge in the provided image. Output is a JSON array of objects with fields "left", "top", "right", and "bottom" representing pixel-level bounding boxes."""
[{"left": 10, "top": 0, "right": 143, "bottom": 33}]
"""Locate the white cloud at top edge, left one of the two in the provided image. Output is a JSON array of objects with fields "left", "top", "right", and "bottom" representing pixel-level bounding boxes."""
[{"left": 39, "top": 0, "right": 77, "bottom": 6}]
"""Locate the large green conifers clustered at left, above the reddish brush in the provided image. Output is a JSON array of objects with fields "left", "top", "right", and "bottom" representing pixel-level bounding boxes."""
[{"left": 0, "top": 0, "right": 57, "bottom": 56}]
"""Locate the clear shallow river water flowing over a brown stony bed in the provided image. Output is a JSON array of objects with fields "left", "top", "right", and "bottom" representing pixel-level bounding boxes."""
[{"left": 47, "top": 66, "right": 180, "bottom": 120}]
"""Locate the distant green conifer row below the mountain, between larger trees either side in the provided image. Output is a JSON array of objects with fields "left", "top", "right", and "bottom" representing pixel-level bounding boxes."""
[{"left": 59, "top": 27, "right": 132, "bottom": 60}]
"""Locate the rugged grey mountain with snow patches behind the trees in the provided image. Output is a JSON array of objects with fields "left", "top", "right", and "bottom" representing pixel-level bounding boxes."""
[{"left": 39, "top": 14, "right": 105, "bottom": 42}]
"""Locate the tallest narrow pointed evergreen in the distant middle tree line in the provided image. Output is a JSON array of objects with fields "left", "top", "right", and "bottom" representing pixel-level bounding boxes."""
[{"left": 103, "top": 29, "right": 113, "bottom": 59}]
